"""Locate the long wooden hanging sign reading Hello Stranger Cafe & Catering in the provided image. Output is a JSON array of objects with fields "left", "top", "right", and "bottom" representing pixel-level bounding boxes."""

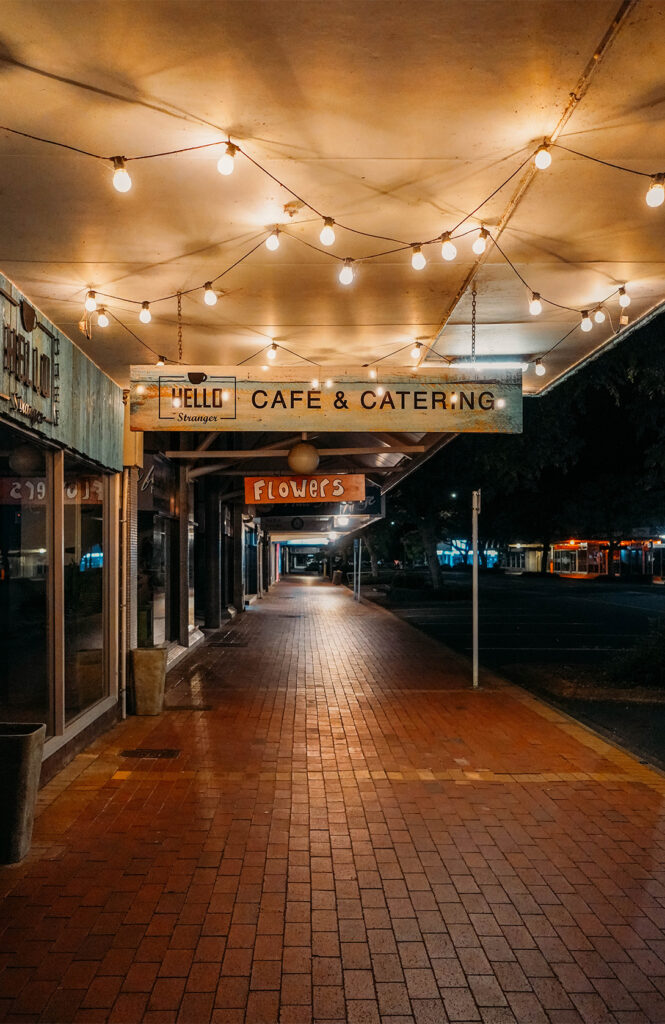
[{"left": 130, "top": 366, "right": 522, "bottom": 433}]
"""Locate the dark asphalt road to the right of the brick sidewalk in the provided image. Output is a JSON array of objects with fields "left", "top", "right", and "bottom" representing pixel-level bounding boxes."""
[{"left": 363, "top": 572, "right": 665, "bottom": 769}]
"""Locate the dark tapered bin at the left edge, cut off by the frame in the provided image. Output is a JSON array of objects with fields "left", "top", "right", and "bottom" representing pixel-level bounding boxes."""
[{"left": 0, "top": 722, "right": 46, "bottom": 864}]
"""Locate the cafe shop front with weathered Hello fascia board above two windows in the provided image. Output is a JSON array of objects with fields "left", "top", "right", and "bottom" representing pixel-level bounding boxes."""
[{"left": 0, "top": 276, "right": 122, "bottom": 770}]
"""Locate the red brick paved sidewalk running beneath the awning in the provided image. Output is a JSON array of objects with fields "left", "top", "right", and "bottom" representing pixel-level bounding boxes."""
[{"left": 0, "top": 580, "right": 665, "bottom": 1024}]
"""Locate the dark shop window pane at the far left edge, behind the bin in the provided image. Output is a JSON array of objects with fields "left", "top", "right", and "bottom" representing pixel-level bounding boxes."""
[{"left": 0, "top": 427, "right": 53, "bottom": 735}]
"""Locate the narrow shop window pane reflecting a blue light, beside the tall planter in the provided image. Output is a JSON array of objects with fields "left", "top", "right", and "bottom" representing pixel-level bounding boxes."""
[{"left": 64, "top": 456, "right": 108, "bottom": 722}]
